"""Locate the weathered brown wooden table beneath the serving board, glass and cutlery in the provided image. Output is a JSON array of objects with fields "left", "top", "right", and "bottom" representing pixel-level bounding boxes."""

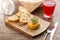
[{"left": 0, "top": 0, "right": 60, "bottom": 40}]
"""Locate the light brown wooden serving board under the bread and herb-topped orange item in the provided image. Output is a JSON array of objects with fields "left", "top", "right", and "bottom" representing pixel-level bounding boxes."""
[{"left": 5, "top": 14, "right": 50, "bottom": 37}]
